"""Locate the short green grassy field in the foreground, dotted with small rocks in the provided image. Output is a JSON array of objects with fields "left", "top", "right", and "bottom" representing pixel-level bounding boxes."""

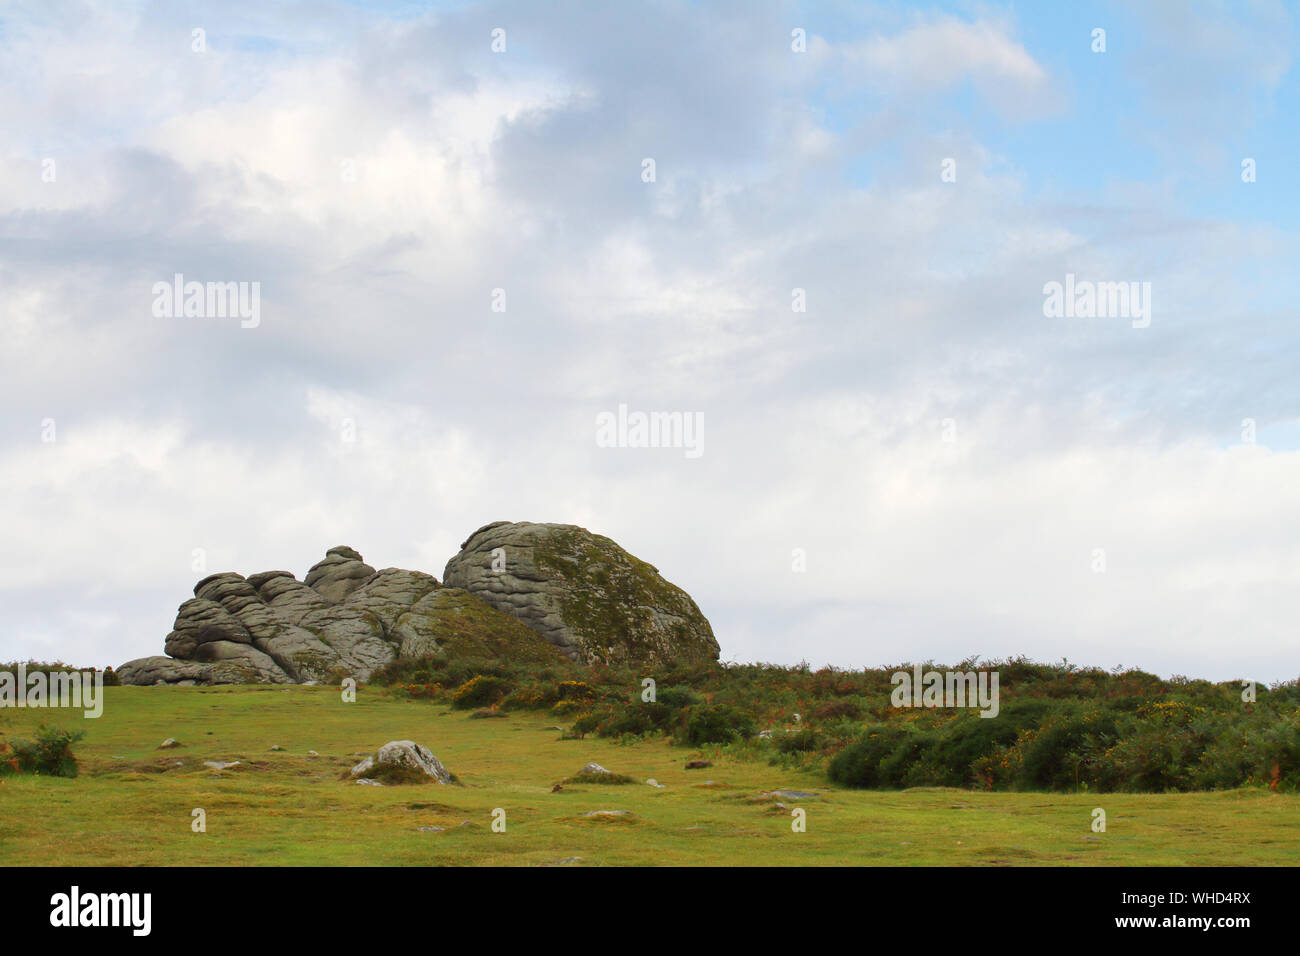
[{"left": 0, "top": 687, "right": 1300, "bottom": 866}]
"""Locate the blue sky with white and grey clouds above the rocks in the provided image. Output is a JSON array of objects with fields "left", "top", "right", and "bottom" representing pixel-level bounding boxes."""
[{"left": 0, "top": 0, "right": 1300, "bottom": 682}]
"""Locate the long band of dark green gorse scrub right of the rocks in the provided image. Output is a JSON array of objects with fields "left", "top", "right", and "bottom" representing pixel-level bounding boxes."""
[{"left": 361, "top": 657, "right": 1300, "bottom": 792}]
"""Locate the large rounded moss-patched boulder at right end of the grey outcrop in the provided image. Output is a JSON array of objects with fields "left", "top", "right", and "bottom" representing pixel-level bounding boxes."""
[{"left": 443, "top": 522, "right": 719, "bottom": 665}]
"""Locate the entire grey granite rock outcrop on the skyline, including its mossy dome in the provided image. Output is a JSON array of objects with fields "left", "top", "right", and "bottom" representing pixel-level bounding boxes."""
[{"left": 118, "top": 522, "right": 718, "bottom": 684}]
